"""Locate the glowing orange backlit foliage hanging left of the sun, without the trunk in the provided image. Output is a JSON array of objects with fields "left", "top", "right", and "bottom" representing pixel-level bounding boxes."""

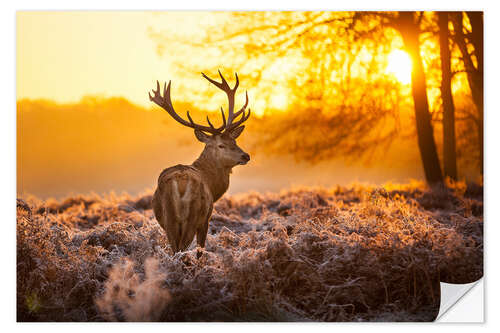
[{"left": 190, "top": 12, "right": 404, "bottom": 163}]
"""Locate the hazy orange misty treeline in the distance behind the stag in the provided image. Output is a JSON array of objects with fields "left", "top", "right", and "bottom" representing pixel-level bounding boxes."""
[{"left": 17, "top": 97, "right": 476, "bottom": 198}]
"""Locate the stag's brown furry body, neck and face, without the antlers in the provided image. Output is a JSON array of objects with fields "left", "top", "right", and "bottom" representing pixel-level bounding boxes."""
[{"left": 153, "top": 131, "right": 249, "bottom": 252}]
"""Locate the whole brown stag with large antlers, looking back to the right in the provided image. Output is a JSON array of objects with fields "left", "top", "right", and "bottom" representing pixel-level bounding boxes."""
[{"left": 148, "top": 70, "right": 250, "bottom": 258}]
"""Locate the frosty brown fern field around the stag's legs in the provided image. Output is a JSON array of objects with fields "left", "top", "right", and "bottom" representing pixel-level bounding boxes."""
[{"left": 17, "top": 183, "right": 483, "bottom": 321}]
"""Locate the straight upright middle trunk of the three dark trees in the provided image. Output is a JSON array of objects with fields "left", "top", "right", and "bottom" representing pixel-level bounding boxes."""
[{"left": 438, "top": 12, "right": 457, "bottom": 180}]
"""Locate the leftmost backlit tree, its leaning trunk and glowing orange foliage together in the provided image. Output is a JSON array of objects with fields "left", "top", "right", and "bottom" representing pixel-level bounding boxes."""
[{"left": 150, "top": 12, "right": 462, "bottom": 183}]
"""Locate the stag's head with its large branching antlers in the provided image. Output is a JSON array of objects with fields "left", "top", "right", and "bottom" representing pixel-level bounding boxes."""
[{"left": 149, "top": 71, "right": 250, "bottom": 168}]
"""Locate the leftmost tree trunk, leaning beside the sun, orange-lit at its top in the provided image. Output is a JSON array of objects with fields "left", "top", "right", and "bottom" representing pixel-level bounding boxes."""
[{"left": 395, "top": 12, "right": 443, "bottom": 184}]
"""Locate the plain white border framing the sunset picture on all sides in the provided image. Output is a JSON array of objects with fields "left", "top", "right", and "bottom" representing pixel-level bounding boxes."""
[{"left": 4, "top": 0, "right": 500, "bottom": 333}]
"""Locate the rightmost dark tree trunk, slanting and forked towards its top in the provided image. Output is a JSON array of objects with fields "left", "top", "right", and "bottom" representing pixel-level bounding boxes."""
[{"left": 451, "top": 12, "right": 484, "bottom": 175}]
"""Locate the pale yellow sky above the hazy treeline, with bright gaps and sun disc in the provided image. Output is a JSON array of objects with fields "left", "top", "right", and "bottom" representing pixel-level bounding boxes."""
[{"left": 17, "top": 11, "right": 422, "bottom": 114}]
